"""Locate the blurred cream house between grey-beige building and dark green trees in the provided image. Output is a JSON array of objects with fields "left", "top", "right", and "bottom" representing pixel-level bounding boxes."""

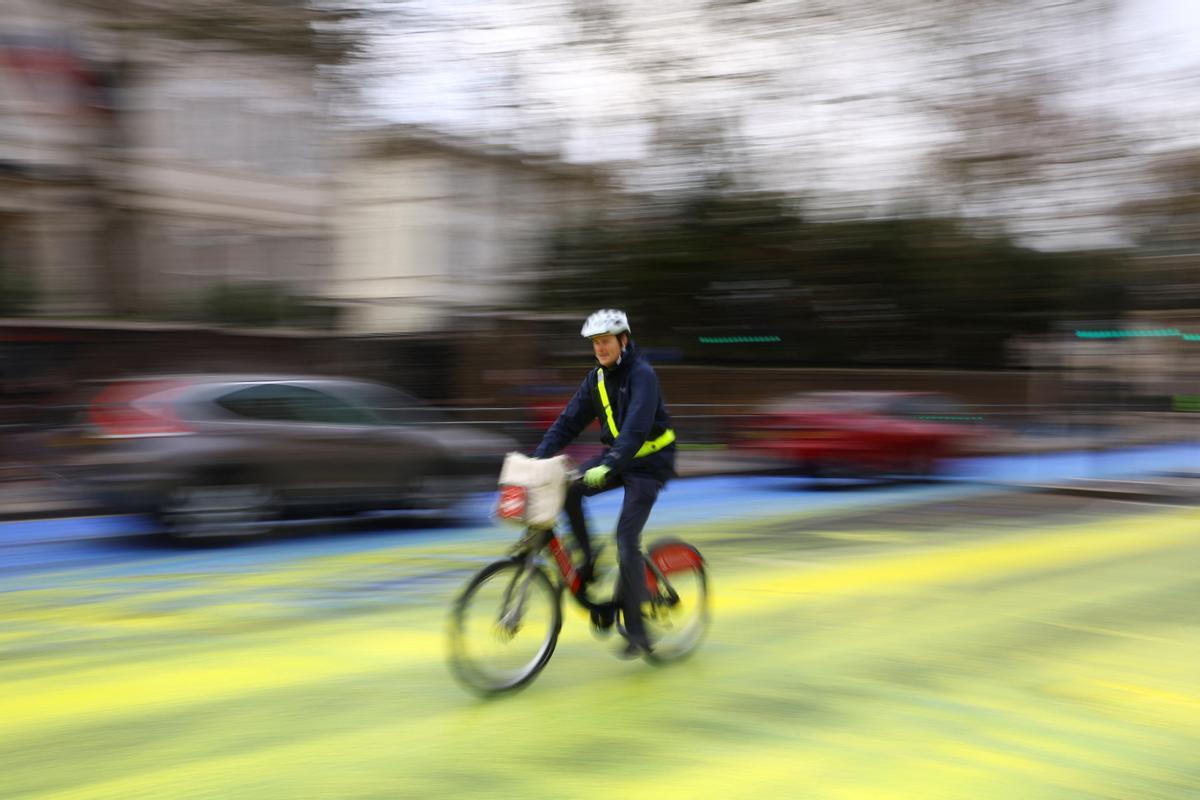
[{"left": 325, "top": 127, "right": 613, "bottom": 333}]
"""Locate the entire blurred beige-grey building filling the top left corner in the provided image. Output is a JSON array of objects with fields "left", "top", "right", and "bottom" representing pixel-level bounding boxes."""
[{"left": 0, "top": 0, "right": 332, "bottom": 318}]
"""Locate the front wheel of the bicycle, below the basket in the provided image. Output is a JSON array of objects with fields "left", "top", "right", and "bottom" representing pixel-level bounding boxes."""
[{"left": 449, "top": 559, "right": 563, "bottom": 694}]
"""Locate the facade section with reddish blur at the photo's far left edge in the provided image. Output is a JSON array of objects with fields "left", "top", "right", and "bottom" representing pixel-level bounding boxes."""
[{"left": 0, "top": 0, "right": 112, "bottom": 315}]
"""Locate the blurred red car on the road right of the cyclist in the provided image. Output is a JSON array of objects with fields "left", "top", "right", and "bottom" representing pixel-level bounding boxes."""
[{"left": 734, "top": 391, "right": 984, "bottom": 476}]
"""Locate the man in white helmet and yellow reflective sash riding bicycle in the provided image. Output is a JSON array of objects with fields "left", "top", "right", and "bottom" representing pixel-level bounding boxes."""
[{"left": 534, "top": 308, "right": 676, "bottom": 657}]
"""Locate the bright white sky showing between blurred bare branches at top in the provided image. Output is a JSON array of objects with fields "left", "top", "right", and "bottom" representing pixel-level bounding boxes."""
[{"left": 357, "top": 0, "right": 1200, "bottom": 245}]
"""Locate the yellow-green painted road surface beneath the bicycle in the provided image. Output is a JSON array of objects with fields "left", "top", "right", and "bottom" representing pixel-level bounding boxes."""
[{"left": 0, "top": 495, "right": 1200, "bottom": 800}]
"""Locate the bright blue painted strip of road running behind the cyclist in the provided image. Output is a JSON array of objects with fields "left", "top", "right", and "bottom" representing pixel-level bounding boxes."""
[{"left": 0, "top": 443, "right": 1200, "bottom": 582}]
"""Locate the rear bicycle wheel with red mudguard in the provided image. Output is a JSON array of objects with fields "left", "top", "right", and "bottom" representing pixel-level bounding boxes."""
[{"left": 646, "top": 540, "right": 709, "bottom": 663}]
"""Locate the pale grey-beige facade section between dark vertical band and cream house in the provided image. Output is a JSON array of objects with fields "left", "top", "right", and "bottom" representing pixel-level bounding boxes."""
[{"left": 110, "top": 36, "right": 331, "bottom": 315}]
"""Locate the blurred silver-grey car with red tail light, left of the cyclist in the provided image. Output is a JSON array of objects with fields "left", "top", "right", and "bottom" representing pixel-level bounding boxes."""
[{"left": 45, "top": 375, "right": 516, "bottom": 537}]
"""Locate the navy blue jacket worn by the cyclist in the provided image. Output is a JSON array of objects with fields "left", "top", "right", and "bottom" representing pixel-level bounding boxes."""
[{"left": 534, "top": 342, "right": 676, "bottom": 482}]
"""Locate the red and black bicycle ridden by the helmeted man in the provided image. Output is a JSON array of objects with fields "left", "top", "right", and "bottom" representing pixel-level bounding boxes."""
[{"left": 449, "top": 503, "right": 708, "bottom": 696}]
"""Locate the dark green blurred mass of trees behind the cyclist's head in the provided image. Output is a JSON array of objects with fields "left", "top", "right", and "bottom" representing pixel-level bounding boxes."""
[{"left": 539, "top": 186, "right": 1124, "bottom": 367}]
